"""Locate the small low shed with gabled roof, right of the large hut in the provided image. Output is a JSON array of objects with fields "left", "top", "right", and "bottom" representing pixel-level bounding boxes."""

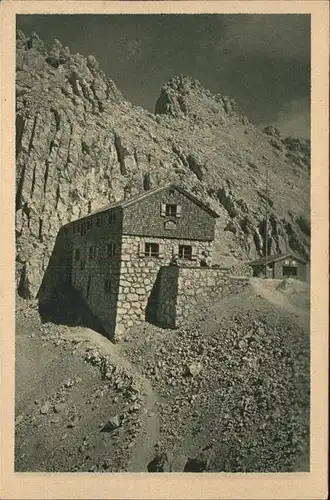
[{"left": 248, "top": 253, "right": 309, "bottom": 281}]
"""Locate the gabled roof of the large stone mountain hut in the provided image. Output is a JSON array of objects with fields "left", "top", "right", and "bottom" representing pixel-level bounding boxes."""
[{"left": 66, "top": 183, "right": 219, "bottom": 224}]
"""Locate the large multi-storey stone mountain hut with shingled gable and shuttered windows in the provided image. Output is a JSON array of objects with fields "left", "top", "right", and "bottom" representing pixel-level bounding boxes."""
[{"left": 65, "top": 184, "right": 222, "bottom": 337}]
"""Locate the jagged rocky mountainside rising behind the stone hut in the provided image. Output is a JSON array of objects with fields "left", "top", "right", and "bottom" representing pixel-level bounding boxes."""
[{"left": 16, "top": 32, "right": 310, "bottom": 297}]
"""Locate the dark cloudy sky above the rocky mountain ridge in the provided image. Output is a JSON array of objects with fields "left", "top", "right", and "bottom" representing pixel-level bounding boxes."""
[{"left": 17, "top": 14, "right": 310, "bottom": 138}]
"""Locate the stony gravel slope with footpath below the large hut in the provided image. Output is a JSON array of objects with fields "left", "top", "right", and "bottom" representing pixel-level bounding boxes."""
[{"left": 15, "top": 280, "right": 309, "bottom": 472}]
